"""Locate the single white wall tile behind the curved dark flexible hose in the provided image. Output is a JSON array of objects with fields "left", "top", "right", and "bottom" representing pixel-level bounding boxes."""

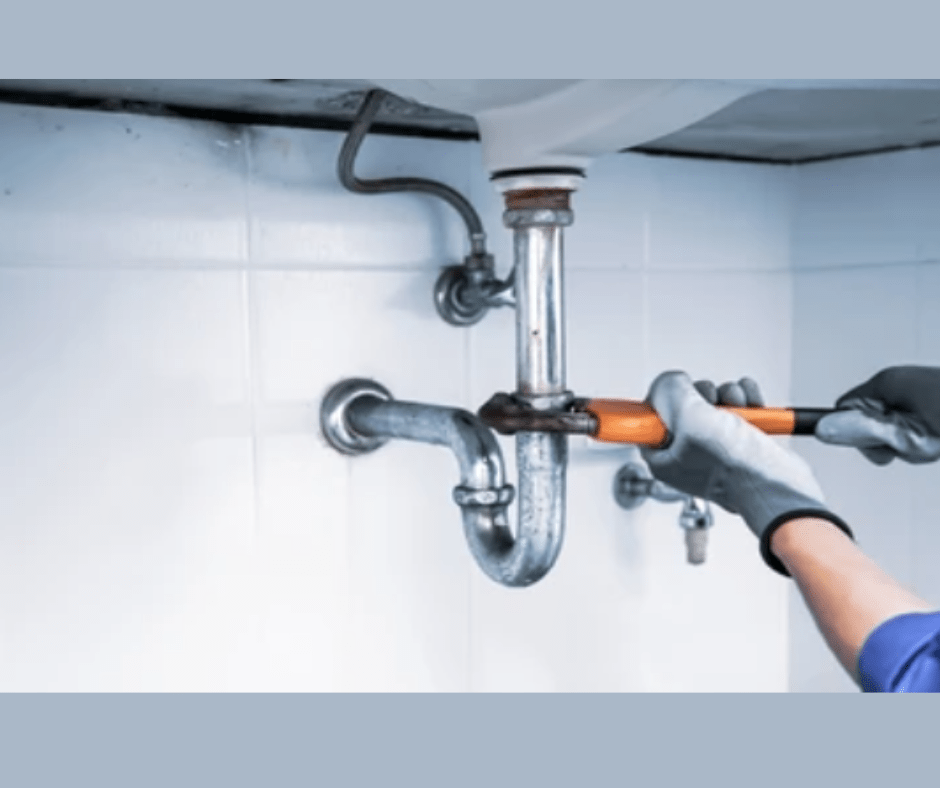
[{"left": 246, "top": 128, "right": 470, "bottom": 270}]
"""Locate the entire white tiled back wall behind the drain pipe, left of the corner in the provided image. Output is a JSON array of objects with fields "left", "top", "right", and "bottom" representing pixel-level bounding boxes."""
[{"left": 0, "top": 98, "right": 791, "bottom": 691}]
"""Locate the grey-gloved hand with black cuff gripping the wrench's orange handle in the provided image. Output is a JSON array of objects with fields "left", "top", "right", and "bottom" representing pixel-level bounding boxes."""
[{"left": 642, "top": 372, "right": 852, "bottom": 576}]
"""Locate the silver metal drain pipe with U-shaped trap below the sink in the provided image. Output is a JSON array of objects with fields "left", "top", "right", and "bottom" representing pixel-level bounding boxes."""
[{"left": 320, "top": 173, "right": 580, "bottom": 587}]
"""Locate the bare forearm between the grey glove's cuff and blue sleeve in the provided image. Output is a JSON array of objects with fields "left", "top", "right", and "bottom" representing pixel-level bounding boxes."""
[{"left": 771, "top": 518, "right": 935, "bottom": 681}]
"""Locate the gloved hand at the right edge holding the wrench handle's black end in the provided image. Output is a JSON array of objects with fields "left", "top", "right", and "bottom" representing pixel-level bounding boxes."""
[{"left": 816, "top": 366, "right": 940, "bottom": 465}]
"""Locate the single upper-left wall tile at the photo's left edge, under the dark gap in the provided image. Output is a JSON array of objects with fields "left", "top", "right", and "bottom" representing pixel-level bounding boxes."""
[{"left": 0, "top": 105, "right": 248, "bottom": 267}]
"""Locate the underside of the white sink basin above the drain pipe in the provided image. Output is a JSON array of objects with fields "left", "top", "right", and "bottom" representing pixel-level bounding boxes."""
[{"left": 373, "top": 79, "right": 928, "bottom": 173}]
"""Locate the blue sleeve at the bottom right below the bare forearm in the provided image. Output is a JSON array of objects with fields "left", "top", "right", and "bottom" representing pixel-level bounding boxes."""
[{"left": 858, "top": 613, "right": 940, "bottom": 692}]
